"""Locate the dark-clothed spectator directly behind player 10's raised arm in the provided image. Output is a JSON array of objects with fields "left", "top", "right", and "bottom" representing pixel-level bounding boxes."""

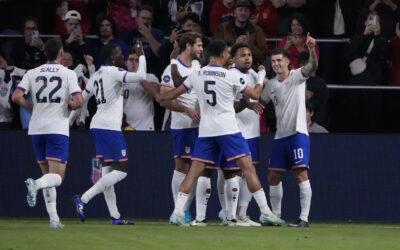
[{"left": 299, "top": 51, "right": 329, "bottom": 127}]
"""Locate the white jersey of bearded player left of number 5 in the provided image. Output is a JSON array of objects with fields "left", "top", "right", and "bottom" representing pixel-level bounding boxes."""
[{"left": 161, "top": 59, "right": 200, "bottom": 129}]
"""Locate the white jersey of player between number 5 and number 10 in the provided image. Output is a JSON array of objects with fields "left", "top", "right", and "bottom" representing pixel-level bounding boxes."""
[{"left": 229, "top": 68, "right": 260, "bottom": 139}]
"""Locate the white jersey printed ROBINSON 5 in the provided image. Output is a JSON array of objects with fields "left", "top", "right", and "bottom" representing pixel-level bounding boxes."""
[{"left": 184, "top": 65, "right": 247, "bottom": 137}]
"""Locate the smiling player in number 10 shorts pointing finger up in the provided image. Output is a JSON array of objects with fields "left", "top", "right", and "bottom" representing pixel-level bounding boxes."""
[{"left": 261, "top": 34, "right": 318, "bottom": 227}]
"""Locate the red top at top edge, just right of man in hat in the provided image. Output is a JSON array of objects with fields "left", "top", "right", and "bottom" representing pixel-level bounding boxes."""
[{"left": 252, "top": 0, "right": 279, "bottom": 38}]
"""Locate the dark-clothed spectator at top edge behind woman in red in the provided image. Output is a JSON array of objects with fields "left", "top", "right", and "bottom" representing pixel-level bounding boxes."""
[{"left": 271, "top": 0, "right": 308, "bottom": 36}]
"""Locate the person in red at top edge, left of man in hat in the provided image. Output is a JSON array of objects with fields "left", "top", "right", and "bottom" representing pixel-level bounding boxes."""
[{"left": 209, "top": 0, "right": 235, "bottom": 35}]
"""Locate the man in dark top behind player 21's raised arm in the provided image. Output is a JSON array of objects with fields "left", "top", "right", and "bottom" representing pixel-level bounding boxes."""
[{"left": 124, "top": 6, "right": 165, "bottom": 75}]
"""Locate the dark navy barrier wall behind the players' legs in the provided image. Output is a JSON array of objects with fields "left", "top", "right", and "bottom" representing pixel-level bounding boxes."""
[{"left": 0, "top": 130, "right": 400, "bottom": 221}]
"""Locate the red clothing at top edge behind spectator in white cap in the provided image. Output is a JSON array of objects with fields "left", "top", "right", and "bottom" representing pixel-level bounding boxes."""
[{"left": 55, "top": 0, "right": 92, "bottom": 34}]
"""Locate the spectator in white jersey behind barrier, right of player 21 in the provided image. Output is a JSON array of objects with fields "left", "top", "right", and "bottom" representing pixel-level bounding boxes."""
[{"left": 123, "top": 49, "right": 160, "bottom": 131}]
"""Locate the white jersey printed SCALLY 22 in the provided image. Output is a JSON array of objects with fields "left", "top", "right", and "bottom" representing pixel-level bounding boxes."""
[{"left": 18, "top": 63, "right": 81, "bottom": 136}]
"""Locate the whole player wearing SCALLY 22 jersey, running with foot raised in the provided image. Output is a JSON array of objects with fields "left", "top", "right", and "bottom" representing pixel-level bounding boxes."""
[{"left": 12, "top": 39, "right": 82, "bottom": 228}]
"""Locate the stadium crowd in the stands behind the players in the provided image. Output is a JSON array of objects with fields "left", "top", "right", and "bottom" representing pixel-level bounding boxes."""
[{"left": 0, "top": 0, "right": 400, "bottom": 132}]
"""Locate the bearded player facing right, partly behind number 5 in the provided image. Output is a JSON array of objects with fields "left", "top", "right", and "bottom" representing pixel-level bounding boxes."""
[{"left": 160, "top": 33, "right": 203, "bottom": 221}]
